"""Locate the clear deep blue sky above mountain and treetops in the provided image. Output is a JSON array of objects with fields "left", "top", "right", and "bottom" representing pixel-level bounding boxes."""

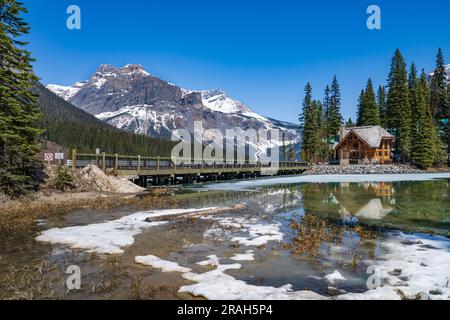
[{"left": 25, "top": 0, "right": 450, "bottom": 122}]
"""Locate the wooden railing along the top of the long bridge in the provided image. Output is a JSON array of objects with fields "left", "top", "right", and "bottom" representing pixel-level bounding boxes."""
[{"left": 72, "top": 150, "right": 308, "bottom": 173}]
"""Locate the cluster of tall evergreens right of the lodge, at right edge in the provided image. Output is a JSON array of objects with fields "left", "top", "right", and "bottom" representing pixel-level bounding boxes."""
[{"left": 384, "top": 49, "right": 449, "bottom": 168}]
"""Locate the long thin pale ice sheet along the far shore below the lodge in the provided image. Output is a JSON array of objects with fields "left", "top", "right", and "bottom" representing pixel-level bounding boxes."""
[{"left": 202, "top": 172, "right": 450, "bottom": 190}]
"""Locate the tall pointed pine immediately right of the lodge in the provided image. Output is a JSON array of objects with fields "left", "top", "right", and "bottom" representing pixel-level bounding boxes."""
[{"left": 386, "top": 49, "right": 411, "bottom": 161}]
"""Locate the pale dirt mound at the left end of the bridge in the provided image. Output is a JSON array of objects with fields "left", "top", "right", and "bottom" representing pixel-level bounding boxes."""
[{"left": 71, "top": 165, "right": 145, "bottom": 193}]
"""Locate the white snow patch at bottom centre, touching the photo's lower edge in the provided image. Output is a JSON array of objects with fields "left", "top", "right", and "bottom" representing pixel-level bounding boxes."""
[{"left": 178, "top": 263, "right": 325, "bottom": 300}]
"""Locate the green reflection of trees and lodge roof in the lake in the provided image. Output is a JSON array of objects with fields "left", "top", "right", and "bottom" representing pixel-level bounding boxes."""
[{"left": 300, "top": 180, "right": 450, "bottom": 230}]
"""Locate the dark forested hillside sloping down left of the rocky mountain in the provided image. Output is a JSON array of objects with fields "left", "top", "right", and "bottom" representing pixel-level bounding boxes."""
[{"left": 34, "top": 83, "right": 174, "bottom": 156}]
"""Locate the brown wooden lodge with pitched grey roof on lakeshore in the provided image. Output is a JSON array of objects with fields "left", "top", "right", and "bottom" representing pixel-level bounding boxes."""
[{"left": 333, "top": 126, "right": 394, "bottom": 165}]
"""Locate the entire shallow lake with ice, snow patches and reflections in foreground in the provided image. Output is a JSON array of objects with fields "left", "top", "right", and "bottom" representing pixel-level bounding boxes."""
[{"left": 0, "top": 174, "right": 450, "bottom": 299}]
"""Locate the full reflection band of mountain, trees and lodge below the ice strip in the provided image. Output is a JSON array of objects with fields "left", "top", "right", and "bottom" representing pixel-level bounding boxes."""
[{"left": 184, "top": 180, "right": 450, "bottom": 231}]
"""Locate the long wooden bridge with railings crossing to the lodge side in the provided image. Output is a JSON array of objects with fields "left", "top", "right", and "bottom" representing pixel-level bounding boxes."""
[{"left": 72, "top": 150, "right": 308, "bottom": 187}]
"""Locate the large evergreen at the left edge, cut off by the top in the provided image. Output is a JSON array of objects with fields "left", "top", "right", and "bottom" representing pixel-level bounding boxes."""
[{"left": 0, "top": 0, "right": 41, "bottom": 196}]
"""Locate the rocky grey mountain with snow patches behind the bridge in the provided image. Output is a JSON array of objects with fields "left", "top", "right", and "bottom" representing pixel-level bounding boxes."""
[{"left": 47, "top": 65, "right": 300, "bottom": 158}]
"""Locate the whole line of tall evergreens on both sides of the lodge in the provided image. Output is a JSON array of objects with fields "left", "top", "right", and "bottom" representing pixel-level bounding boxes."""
[{"left": 299, "top": 49, "right": 450, "bottom": 168}]
